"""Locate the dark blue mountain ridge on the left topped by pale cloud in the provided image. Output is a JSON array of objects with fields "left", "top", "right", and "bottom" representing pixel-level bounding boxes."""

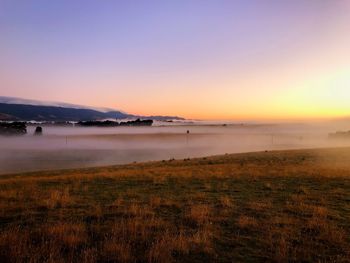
[{"left": 0, "top": 97, "right": 182, "bottom": 122}]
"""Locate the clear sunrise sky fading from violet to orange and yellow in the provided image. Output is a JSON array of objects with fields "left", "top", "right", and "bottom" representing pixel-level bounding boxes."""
[{"left": 0, "top": 0, "right": 350, "bottom": 120}]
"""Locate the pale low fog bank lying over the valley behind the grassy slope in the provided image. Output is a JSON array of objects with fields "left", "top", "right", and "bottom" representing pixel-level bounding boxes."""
[{"left": 0, "top": 123, "right": 350, "bottom": 174}]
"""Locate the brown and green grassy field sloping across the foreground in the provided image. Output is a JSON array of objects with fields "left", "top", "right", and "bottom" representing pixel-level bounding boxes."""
[{"left": 0, "top": 148, "right": 350, "bottom": 262}]
